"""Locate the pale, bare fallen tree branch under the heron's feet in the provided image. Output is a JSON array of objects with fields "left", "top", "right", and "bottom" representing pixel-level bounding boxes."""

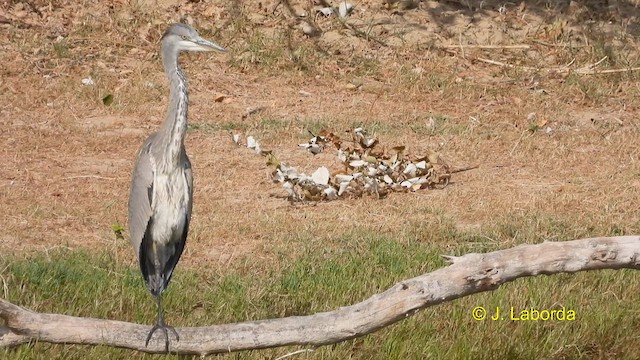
[{"left": 0, "top": 236, "right": 640, "bottom": 355}]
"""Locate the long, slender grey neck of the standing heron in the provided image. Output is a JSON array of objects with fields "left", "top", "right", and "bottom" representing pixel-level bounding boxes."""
[{"left": 163, "top": 57, "right": 189, "bottom": 169}]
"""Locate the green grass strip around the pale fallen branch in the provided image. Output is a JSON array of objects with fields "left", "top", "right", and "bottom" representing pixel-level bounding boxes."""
[{"left": 0, "top": 224, "right": 640, "bottom": 359}]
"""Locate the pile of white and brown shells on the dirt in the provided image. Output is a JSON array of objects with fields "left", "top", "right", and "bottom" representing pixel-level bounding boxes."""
[{"left": 233, "top": 128, "right": 450, "bottom": 202}]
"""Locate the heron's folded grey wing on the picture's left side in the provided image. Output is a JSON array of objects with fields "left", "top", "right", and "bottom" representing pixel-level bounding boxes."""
[{"left": 129, "top": 133, "right": 156, "bottom": 256}]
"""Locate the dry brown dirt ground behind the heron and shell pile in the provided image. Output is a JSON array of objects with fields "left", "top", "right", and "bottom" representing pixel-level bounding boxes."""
[{"left": 0, "top": 0, "right": 640, "bottom": 265}]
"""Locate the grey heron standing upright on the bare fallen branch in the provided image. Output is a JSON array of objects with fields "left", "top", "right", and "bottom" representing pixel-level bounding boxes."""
[{"left": 129, "top": 24, "right": 225, "bottom": 352}]
